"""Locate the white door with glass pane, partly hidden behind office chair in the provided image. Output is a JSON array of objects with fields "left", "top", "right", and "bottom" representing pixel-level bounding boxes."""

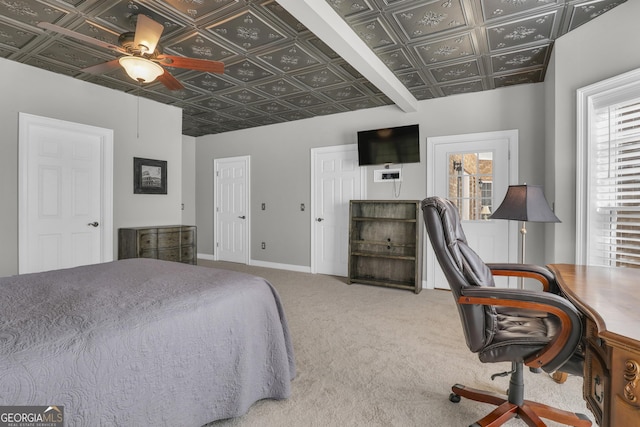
[{"left": 426, "top": 131, "right": 518, "bottom": 289}]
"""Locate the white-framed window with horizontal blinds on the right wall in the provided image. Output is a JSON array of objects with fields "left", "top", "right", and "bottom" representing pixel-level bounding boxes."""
[{"left": 576, "top": 67, "right": 640, "bottom": 268}]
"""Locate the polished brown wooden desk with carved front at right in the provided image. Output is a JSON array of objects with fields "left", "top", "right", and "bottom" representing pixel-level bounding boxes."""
[{"left": 549, "top": 264, "right": 640, "bottom": 427}]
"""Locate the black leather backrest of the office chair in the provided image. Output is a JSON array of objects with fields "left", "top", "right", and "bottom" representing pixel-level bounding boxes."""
[{"left": 422, "top": 197, "right": 496, "bottom": 352}]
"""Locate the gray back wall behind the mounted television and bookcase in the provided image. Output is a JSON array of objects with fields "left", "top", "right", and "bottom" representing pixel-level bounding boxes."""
[{"left": 196, "top": 83, "right": 544, "bottom": 267}]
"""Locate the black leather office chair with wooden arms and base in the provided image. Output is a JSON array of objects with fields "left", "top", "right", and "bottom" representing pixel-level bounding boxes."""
[{"left": 422, "top": 197, "right": 591, "bottom": 427}]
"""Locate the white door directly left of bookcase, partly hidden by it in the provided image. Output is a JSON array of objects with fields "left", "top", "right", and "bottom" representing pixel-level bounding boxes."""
[{"left": 311, "top": 144, "right": 364, "bottom": 277}]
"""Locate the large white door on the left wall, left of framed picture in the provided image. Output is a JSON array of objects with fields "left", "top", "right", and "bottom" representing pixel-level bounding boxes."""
[{"left": 19, "top": 114, "right": 113, "bottom": 274}]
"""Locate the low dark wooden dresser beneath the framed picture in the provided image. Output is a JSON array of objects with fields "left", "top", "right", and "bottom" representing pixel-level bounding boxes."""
[{"left": 118, "top": 225, "right": 197, "bottom": 264}]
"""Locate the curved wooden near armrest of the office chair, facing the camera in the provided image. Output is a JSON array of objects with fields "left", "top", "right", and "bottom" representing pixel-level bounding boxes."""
[{"left": 458, "top": 287, "right": 582, "bottom": 370}]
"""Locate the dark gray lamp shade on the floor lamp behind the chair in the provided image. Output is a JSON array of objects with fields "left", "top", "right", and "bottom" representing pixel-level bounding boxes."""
[{"left": 489, "top": 184, "right": 560, "bottom": 222}]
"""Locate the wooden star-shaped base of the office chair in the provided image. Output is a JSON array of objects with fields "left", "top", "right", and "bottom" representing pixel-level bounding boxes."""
[{"left": 449, "top": 384, "right": 591, "bottom": 427}]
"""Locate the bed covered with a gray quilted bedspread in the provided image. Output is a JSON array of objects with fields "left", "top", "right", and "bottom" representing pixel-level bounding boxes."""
[{"left": 0, "top": 259, "right": 295, "bottom": 427}]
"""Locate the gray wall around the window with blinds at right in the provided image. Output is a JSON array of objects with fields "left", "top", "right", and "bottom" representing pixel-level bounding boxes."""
[{"left": 545, "top": 1, "right": 640, "bottom": 263}]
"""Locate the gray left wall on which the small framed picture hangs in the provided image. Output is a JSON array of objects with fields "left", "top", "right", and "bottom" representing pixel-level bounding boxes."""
[{"left": 0, "top": 58, "right": 182, "bottom": 276}]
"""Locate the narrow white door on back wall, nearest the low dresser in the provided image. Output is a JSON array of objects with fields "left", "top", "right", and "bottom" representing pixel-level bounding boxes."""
[{"left": 213, "top": 156, "right": 250, "bottom": 264}]
